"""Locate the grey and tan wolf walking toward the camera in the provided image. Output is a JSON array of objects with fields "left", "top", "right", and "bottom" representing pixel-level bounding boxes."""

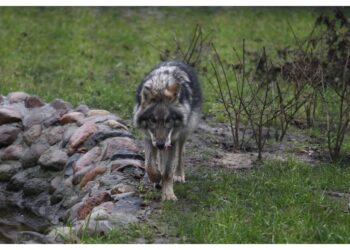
[{"left": 133, "top": 61, "right": 202, "bottom": 201}]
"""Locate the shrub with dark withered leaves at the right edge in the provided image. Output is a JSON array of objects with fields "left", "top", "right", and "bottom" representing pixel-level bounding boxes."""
[{"left": 280, "top": 8, "right": 350, "bottom": 161}]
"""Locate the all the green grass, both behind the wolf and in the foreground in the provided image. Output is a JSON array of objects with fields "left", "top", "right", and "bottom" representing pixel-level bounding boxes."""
[{"left": 0, "top": 7, "right": 350, "bottom": 243}]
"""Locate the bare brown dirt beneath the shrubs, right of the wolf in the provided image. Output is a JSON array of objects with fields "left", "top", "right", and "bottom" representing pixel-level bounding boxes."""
[{"left": 185, "top": 118, "right": 320, "bottom": 169}]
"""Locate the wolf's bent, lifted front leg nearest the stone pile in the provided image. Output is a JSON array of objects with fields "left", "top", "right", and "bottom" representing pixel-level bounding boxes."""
[{"left": 145, "top": 139, "right": 161, "bottom": 184}]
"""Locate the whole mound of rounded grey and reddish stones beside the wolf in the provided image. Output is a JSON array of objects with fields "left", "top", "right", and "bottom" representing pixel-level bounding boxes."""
[{"left": 0, "top": 92, "right": 149, "bottom": 240}]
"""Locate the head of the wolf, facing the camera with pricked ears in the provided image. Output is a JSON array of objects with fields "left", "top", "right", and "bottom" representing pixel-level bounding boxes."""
[{"left": 135, "top": 84, "right": 186, "bottom": 149}]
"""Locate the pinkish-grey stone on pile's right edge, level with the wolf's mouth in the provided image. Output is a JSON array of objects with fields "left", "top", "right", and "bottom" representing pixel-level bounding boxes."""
[{"left": 102, "top": 137, "right": 139, "bottom": 160}]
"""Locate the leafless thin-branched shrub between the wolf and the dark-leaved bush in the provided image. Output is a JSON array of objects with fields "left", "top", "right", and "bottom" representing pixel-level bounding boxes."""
[{"left": 208, "top": 40, "right": 307, "bottom": 160}]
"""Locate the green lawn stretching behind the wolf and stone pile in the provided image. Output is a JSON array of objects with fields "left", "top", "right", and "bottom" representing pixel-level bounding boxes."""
[{"left": 0, "top": 7, "right": 329, "bottom": 118}]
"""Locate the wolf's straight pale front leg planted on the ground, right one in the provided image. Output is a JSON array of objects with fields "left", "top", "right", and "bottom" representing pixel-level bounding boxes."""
[{"left": 161, "top": 148, "right": 177, "bottom": 201}]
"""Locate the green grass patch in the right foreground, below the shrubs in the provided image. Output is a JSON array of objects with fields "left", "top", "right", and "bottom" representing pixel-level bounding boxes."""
[{"left": 160, "top": 160, "right": 350, "bottom": 243}]
